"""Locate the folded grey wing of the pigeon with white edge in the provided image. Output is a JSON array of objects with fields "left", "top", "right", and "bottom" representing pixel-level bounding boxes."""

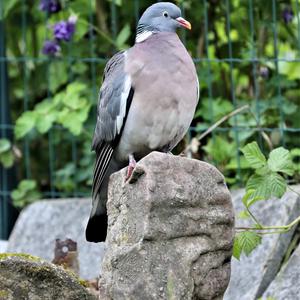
[{"left": 92, "top": 51, "right": 133, "bottom": 199}]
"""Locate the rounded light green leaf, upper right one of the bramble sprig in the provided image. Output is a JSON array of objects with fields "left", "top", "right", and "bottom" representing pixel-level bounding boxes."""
[{"left": 268, "top": 147, "right": 294, "bottom": 176}]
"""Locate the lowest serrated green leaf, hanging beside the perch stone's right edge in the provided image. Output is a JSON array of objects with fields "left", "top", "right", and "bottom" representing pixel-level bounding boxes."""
[{"left": 233, "top": 231, "right": 261, "bottom": 260}]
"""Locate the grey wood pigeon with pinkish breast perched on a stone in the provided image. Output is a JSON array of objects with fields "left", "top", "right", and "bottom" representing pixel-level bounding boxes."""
[{"left": 86, "top": 2, "right": 199, "bottom": 243}]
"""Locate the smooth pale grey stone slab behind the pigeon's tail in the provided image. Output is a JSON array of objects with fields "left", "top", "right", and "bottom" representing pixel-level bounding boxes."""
[{"left": 7, "top": 199, "right": 104, "bottom": 279}]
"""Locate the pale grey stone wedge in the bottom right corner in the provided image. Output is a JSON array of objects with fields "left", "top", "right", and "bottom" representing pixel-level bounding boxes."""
[{"left": 263, "top": 246, "right": 300, "bottom": 300}]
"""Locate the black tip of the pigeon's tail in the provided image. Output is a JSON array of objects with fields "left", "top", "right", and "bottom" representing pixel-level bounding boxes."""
[{"left": 85, "top": 214, "right": 107, "bottom": 243}]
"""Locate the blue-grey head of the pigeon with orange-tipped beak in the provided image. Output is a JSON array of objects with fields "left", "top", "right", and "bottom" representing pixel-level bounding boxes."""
[{"left": 137, "top": 2, "right": 191, "bottom": 34}]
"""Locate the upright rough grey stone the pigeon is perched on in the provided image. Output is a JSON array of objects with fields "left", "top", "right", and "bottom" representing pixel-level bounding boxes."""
[{"left": 99, "top": 152, "right": 234, "bottom": 300}]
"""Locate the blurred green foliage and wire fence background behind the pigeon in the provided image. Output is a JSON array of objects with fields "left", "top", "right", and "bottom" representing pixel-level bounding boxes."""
[{"left": 0, "top": 0, "right": 300, "bottom": 239}]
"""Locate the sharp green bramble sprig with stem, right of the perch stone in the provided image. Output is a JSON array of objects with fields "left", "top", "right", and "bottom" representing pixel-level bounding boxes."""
[{"left": 233, "top": 142, "right": 300, "bottom": 259}]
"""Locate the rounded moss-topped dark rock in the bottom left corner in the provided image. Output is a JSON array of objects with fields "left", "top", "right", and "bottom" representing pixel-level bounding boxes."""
[{"left": 0, "top": 254, "right": 96, "bottom": 300}]
